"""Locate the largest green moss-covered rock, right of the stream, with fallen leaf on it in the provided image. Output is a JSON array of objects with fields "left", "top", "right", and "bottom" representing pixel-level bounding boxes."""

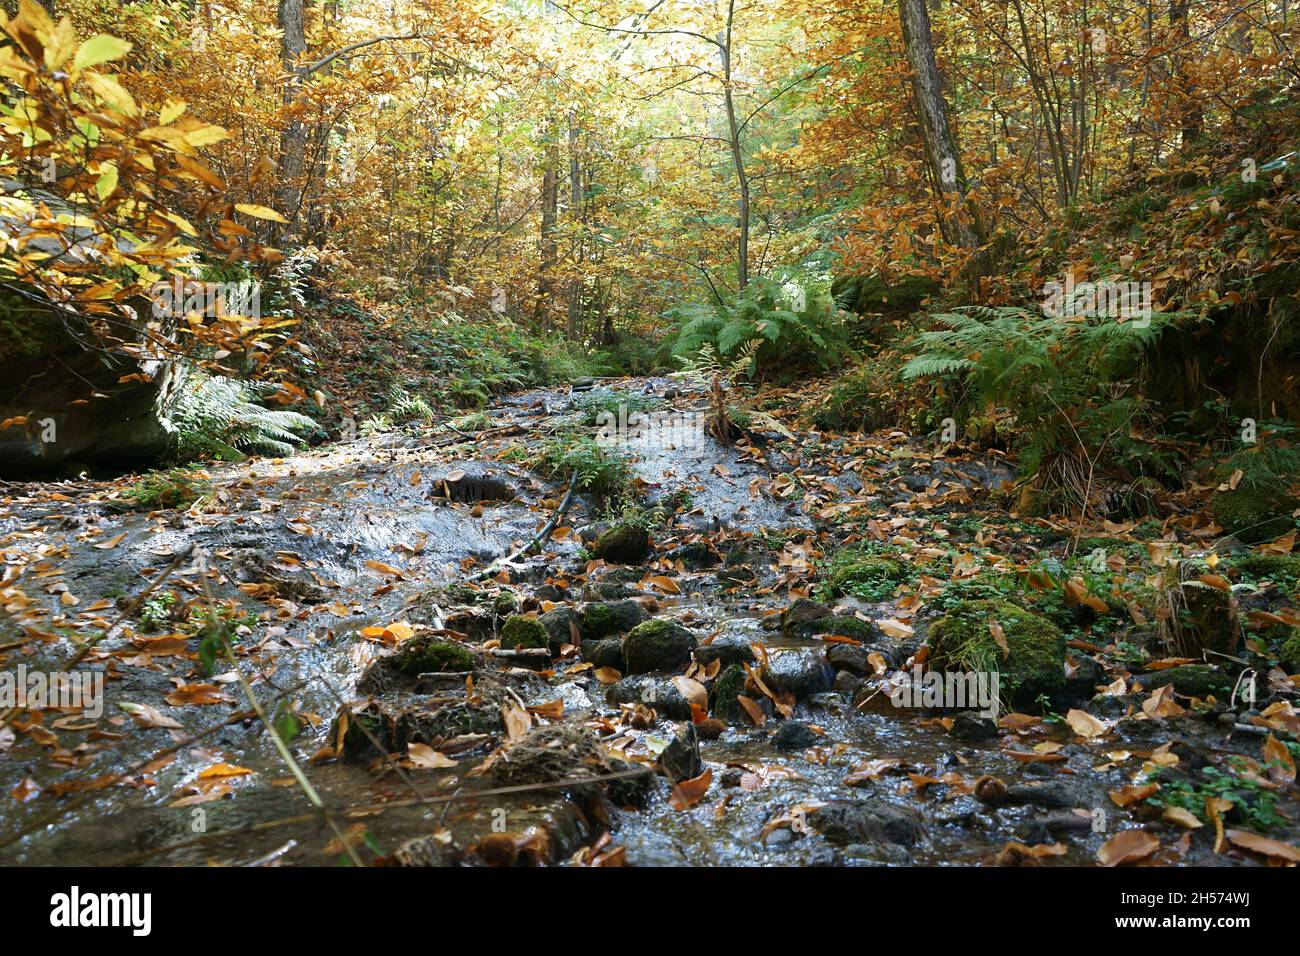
[{"left": 930, "top": 601, "right": 1066, "bottom": 704}]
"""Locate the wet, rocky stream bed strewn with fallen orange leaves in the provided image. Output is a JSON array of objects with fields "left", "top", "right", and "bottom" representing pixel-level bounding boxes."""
[{"left": 0, "top": 378, "right": 1300, "bottom": 865}]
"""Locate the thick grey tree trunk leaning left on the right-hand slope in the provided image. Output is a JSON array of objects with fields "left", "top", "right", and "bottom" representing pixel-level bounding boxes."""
[{"left": 898, "top": 0, "right": 987, "bottom": 248}]
